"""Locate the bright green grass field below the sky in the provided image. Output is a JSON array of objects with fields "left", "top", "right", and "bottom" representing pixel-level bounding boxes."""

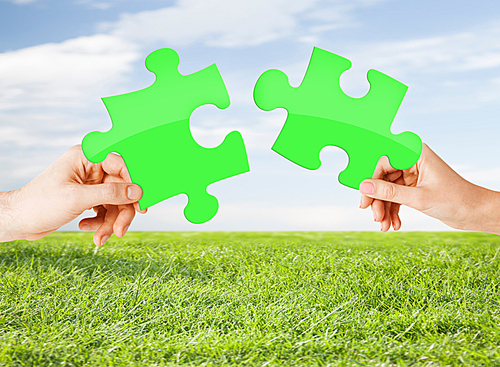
[{"left": 0, "top": 232, "right": 500, "bottom": 366}]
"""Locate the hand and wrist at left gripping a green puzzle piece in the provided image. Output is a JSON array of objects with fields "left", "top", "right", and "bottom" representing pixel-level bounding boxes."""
[{"left": 0, "top": 145, "right": 146, "bottom": 246}]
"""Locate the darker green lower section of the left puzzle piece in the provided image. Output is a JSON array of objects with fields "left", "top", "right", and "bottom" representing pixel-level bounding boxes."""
[{"left": 112, "top": 121, "right": 249, "bottom": 224}]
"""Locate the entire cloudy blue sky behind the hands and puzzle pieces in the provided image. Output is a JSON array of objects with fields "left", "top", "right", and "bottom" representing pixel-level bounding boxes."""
[{"left": 0, "top": 0, "right": 500, "bottom": 230}]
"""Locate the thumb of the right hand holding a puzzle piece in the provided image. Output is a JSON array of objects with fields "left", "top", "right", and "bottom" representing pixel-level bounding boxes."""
[{"left": 359, "top": 179, "right": 422, "bottom": 209}]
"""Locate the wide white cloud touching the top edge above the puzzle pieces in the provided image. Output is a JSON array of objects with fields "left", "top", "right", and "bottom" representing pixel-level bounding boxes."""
[{"left": 101, "top": 0, "right": 382, "bottom": 47}]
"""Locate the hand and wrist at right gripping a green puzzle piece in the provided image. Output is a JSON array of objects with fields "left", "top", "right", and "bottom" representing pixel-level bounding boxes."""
[{"left": 360, "top": 144, "right": 500, "bottom": 233}]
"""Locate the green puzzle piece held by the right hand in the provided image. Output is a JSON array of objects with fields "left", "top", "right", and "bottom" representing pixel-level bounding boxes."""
[{"left": 254, "top": 47, "right": 422, "bottom": 189}]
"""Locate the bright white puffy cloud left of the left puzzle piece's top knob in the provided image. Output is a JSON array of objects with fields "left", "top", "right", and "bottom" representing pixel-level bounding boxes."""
[{"left": 0, "top": 35, "right": 140, "bottom": 110}]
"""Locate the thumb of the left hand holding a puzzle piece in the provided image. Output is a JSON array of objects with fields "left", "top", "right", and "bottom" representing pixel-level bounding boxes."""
[{"left": 78, "top": 182, "right": 142, "bottom": 208}]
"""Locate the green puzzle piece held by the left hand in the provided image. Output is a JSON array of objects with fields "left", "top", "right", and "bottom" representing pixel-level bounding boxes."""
[{"left": 82, "top": 48, "right": 250, "bottom": 223}]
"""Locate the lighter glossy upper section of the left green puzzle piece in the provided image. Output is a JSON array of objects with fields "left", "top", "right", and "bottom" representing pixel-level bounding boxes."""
[{"left": 82, "top": 48, "right": 230, "bottom": 163}]
